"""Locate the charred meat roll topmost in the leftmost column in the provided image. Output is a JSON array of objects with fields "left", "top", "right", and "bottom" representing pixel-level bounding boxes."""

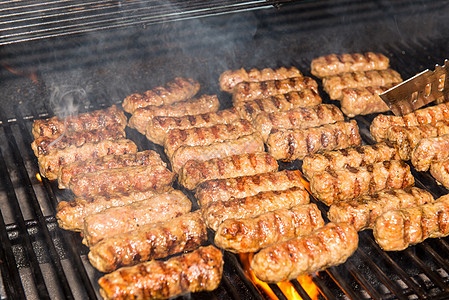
[{"left": 32, "top": 105, "right": 127, "bottom": 139}]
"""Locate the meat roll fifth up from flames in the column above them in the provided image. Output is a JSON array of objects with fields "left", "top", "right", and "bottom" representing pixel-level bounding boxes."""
[{"left": 178, "top": 152, "right": 278, "bottom": 190}]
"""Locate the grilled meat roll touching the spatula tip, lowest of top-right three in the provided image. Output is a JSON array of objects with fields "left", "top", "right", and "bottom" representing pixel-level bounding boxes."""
[{"left": 340, "top": 85, "right": 391, "bottom": 118}]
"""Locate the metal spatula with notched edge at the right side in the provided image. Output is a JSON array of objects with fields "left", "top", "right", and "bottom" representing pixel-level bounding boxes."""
[{"left": 379, "top": 59, "right": 449, "bottom": 116}]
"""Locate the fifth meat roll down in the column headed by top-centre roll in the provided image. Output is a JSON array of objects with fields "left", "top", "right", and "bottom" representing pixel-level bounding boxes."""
[{"left": 266, "top": 120, "right": 362, "bottom": 161}]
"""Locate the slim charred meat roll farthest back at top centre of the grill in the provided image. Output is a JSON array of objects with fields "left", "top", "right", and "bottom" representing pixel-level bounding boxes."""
[{"left": 218, "top": 67, "right": 303, "bottom": 93}]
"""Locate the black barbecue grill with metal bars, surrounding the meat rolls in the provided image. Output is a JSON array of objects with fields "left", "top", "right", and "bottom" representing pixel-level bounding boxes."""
[{"left": 0, "top": 0, "right": 449, "bottom": 300}]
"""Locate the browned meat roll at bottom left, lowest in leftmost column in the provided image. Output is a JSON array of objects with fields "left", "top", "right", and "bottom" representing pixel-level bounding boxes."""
[{"left": 98, "top": 246, "right": 223, "bottom": 300}]
